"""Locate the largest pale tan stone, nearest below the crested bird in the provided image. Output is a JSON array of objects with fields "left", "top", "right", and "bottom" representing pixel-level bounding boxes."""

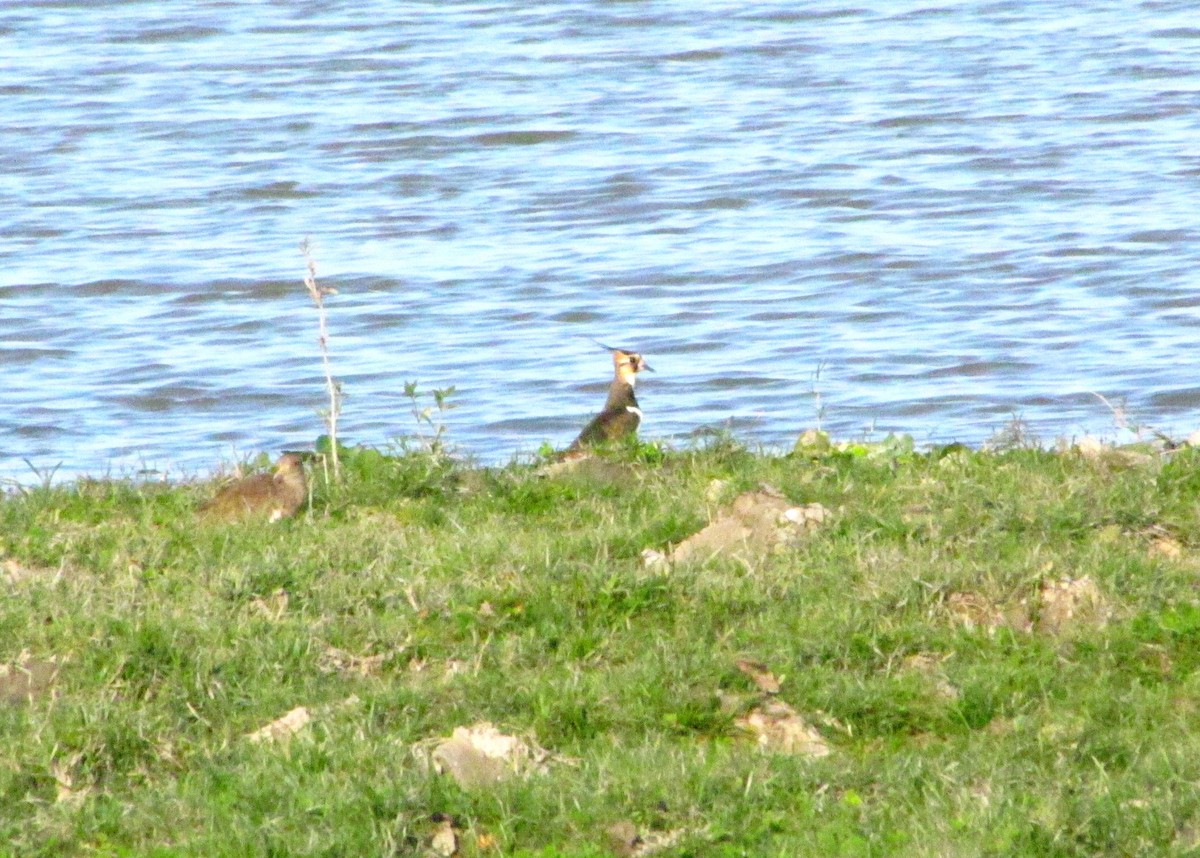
[{"left": 657, "top": 488, "right": 829, "bottom": 568}]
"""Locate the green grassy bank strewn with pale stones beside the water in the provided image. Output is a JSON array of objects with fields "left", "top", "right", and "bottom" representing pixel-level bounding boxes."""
[{"left": 0, "top": 443, "right": 1200, "bottom": 858}]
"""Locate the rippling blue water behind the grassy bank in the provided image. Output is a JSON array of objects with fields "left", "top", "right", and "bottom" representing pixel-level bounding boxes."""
[{"left": 0, "top": 0, "right": 1200, "bottom": 479}]
